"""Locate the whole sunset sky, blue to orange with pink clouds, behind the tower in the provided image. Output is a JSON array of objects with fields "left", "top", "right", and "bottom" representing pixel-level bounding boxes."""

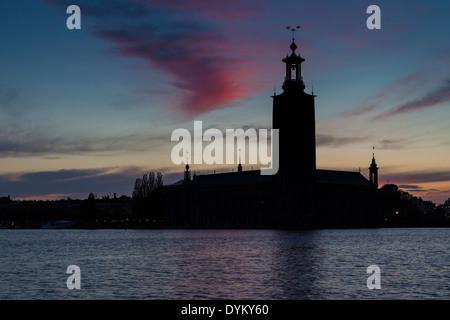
[{"left": 0, "top": 0, "right": 450, "bottom": 204}]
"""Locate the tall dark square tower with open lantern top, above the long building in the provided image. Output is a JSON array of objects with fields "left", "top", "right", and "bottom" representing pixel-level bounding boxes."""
[{"left": 272, "top": 33, "right": 316, "bottom": 221}]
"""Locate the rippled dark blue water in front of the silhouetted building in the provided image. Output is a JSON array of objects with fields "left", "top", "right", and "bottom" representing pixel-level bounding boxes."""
[{"left": 0, "top": 228, "right": 450, "bottom": 300}]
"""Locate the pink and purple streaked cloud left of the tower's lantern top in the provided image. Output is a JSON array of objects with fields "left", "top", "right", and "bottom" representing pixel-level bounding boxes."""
[{"left": 99, "top": 26, "right": 256, "bottom": 116}]
